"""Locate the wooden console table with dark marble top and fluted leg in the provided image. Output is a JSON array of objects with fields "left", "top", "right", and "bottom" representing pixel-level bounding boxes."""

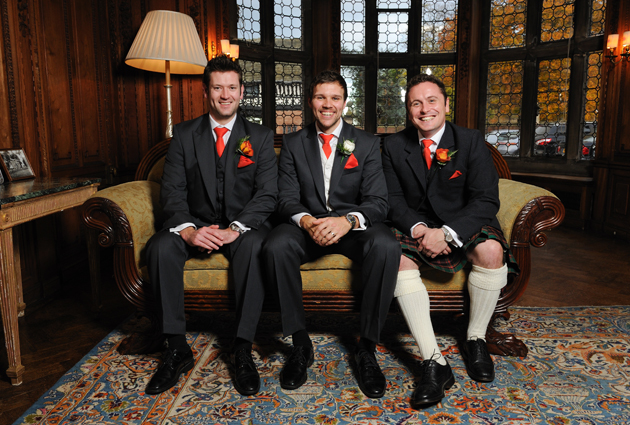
[{"left": 0, "top": 178, "right": 101, "bottom": 385}]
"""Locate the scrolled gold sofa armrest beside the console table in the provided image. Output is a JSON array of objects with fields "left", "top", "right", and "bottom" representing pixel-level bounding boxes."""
[{"left": 83, "top": 180, "right": 162, "bottom": 311}]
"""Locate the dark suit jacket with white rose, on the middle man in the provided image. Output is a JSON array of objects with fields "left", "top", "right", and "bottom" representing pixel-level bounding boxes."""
[{"left": 278, "top": 122, "right": 388, "bottom": 224}]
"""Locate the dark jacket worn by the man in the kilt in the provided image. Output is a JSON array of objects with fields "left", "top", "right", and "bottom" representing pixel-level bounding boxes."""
[{"left": 383, "top": 122, "right": 501, "bottom": 243}]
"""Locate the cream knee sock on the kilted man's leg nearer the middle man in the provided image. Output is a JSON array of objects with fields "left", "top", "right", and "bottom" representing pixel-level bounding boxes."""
[{"left": 394, "top": 270, "right": 446, "bottom": 366}]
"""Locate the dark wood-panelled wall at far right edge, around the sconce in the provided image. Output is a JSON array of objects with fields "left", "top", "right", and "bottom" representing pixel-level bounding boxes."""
[{"left": 593, "top": 0, "right": 630, "bottom": 235}]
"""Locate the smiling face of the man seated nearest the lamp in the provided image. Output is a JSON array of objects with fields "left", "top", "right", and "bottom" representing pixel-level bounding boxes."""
[{"left": 204, "top": 71, "right": 245, "bottom": 125}]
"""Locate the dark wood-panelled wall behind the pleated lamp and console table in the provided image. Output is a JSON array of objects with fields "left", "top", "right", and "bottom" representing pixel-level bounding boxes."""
[{"left": 0, "top": 0, "right": 229, "bottom": 305}]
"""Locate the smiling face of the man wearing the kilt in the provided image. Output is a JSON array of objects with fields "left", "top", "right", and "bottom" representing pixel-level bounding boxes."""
[{"left": 407, "top": 82, "right": 449, "bottom": 139}]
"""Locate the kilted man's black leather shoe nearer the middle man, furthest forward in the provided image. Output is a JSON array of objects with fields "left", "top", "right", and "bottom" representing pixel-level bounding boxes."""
[{"left": 411, "top": 360, "right": 455, "bottom": 406}]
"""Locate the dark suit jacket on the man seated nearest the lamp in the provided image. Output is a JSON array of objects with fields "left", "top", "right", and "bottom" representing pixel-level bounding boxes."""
[{"left": 161, "top": 114, "right": 278, "bottom": 229}]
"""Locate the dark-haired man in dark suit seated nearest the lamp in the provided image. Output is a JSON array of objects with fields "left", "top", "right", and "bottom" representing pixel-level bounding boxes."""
[{"left": 146, "top": 56, "right": 278, "bottom": 395}]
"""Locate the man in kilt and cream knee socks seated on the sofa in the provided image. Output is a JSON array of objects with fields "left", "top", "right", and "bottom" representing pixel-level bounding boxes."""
[{"left": 383, "top": 74, "right": 518, "bottom": 406}]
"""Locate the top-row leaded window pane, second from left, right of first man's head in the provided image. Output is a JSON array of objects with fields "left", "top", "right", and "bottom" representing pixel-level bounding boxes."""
[{"left": 274, "top": 0, "right": 303, "bottom": 50}]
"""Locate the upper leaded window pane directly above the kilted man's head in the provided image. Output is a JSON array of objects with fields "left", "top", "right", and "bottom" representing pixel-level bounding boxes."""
[{"left": 421, "top": 0, "right": 457, "bottom": 53}]
